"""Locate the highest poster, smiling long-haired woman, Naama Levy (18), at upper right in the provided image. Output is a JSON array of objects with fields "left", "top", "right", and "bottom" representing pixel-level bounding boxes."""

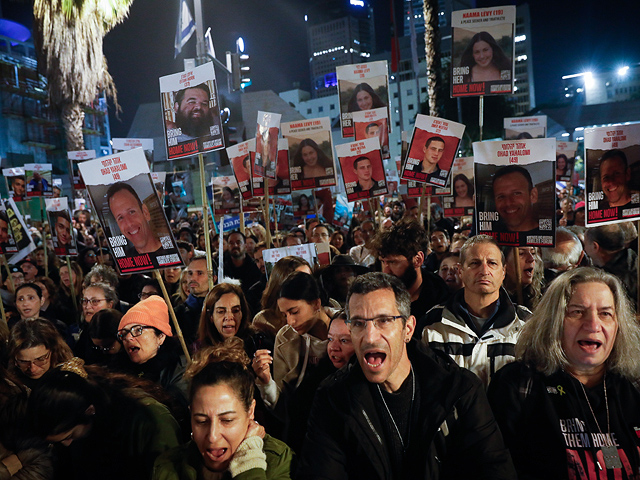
[{"left": 451, "top": 5, "right": 516, "bottom": 97}]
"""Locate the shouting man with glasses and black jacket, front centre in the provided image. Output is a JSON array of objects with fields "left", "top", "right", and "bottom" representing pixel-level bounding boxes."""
[{"left": 297, "top": 272, "right": 515, "bottom": 480}]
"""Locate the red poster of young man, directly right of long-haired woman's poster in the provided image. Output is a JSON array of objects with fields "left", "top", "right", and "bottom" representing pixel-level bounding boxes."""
[{"left": 336, "top": 137, "right": 389, "bottom": 202}]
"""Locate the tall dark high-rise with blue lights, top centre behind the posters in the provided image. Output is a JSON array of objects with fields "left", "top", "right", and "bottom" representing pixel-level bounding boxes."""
[{"left": 305, "top": 0, "right": 375, "bottom": 98}]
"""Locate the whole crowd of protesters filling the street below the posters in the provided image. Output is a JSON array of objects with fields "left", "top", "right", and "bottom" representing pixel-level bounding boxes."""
[{"left": 0, "top": 184, "right": 640, "bottom": 480}]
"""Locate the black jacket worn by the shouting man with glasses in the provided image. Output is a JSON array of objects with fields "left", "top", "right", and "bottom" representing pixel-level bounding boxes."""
[{"left": 298, "top": 341, "right": 515, "bottom": 480}]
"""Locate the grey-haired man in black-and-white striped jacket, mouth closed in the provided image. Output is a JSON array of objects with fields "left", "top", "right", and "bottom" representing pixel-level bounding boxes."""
[{"left": 418, "top": 235, "right": 531, "bottom": 386}]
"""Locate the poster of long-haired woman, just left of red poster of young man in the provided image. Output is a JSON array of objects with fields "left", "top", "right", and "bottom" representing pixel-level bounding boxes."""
[{"left": 280, "top": 117, "right": 336, "bottom": 190}]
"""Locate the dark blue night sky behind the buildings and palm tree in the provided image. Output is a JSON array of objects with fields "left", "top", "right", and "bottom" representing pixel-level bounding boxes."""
[{"left": 2, "top": 0, "right": 640, "bottom": 137}]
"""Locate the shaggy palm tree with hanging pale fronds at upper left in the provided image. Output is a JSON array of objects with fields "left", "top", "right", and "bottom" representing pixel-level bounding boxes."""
[{"left": 33, "top": 0, "right": 133, "bottom": 151}]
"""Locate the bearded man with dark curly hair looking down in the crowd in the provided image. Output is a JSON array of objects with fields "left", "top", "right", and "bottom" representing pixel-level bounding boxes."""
[{"left": 372, "top": 219, "right": 449, "bottom": 337}]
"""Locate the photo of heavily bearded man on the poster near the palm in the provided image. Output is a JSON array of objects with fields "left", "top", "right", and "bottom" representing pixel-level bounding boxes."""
[{"left": 166, "top": 83, "right": 214, "bottom": 142}]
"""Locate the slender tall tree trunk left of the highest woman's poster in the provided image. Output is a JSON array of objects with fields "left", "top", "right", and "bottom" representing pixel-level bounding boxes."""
[{"left": 422, "top": 0, "right": 441, "bottom": 117}]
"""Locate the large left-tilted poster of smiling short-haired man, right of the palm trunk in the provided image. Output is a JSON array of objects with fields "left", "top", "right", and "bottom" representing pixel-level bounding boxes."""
[{"left": 80, "top": 148, "right": 183, "bottom": 273}]
